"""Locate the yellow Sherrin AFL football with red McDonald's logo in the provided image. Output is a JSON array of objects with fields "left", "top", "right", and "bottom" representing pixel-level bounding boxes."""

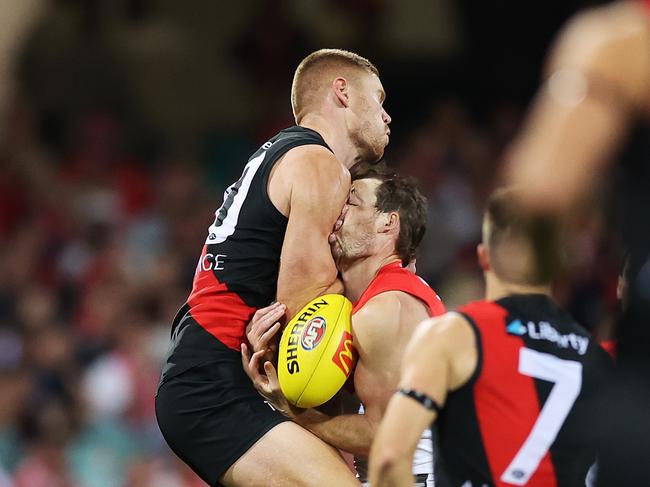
[{"left": 278, "top": 294, "right": 357, "bottom": 408}]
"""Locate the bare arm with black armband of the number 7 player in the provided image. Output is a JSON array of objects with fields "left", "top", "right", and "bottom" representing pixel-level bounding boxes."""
[{"left": 369, "top": 313, "right": 477, "bottom": 487}]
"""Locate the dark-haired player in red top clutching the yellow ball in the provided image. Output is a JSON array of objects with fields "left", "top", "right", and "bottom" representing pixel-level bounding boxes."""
[{"left": 242, "top": 165, "right": 445, "bottom": 486}]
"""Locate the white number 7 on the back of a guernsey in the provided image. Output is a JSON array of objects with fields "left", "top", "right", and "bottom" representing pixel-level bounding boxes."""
[{"left": 501, "top": 347, "right": 582, "bottom": 485}]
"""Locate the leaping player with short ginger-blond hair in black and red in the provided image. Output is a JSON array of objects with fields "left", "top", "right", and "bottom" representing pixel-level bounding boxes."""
[{"left": 156, "top": 49, "right": 391, "bottom": 486}]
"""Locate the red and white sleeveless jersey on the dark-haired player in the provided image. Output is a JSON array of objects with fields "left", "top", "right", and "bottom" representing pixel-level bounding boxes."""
[{"left": 352, "top": 262, "right": 446, "bottom": 482}]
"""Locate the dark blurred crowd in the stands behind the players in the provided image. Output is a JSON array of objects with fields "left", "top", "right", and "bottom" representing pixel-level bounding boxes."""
[{"left": 0, "top": 0, "right": 620, "bottom": 487}]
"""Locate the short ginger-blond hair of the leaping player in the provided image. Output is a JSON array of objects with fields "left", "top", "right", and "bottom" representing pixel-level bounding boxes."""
[{"left": 291, "top": 49, "right": 379, "bottom": 123}]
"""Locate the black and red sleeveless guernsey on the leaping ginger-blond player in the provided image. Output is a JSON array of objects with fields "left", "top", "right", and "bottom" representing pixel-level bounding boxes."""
[{"left": 162, "top": 126, "right": 329, "bottom": 382}]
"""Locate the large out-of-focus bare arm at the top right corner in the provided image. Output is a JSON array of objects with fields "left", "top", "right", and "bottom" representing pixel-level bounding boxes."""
[{"left": 507, "top": 2, "right": 650, "bottom": 212}]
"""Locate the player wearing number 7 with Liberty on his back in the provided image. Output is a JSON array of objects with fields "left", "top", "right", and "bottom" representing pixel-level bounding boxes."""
[{"left": 370, "top": 191, "right": 611, "bottom": 487}]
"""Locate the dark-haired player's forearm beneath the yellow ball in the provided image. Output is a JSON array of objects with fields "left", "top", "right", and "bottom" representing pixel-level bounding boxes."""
[{"left": 293, "top": 409, "right": 375, "bottom": 457}]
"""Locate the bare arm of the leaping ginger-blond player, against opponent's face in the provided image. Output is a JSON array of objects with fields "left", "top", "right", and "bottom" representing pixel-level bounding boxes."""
[{"left": 277, "top": 146, "right": 350, "bottom": 317}]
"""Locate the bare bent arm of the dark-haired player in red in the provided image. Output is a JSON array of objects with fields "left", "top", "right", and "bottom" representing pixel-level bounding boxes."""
[{"left": 293, "top": 292, "right": 401, "bottom": 457}]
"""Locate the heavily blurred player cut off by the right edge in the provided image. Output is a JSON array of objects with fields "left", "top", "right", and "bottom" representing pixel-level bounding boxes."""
[{"left": 508, "top": 0, "right": 650, "bottom": 485}]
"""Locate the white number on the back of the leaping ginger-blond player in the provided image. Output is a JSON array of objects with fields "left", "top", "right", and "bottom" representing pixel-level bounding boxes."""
[{"left": 205, "top": 151, "right": 266, "bottom": 244}]
